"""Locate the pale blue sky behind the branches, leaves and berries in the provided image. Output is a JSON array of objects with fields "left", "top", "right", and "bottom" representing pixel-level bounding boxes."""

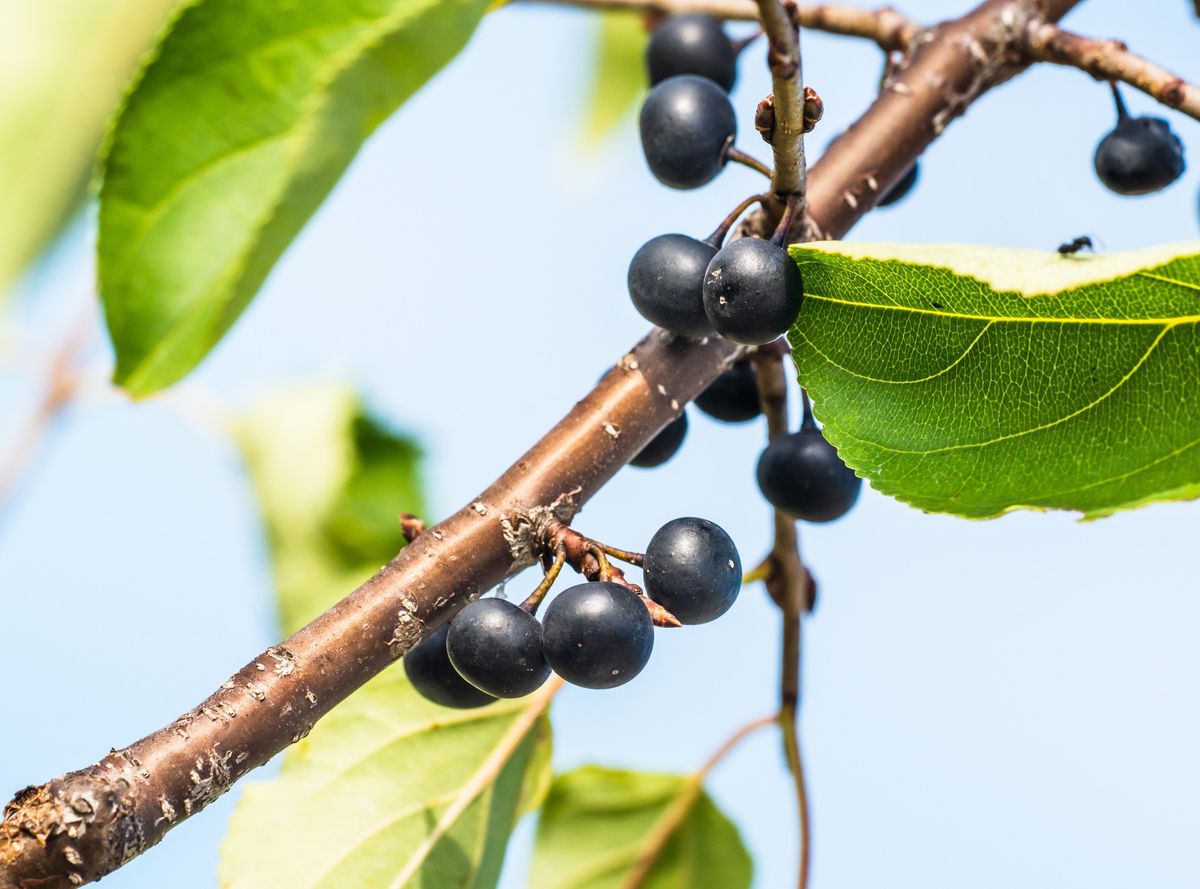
[{"left": 0, "top": 0, "right": 1200, "bottom": 889}]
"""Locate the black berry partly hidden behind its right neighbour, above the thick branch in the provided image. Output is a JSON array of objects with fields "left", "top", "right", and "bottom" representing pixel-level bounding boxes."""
[{"left": 626, "top": 235, "right": 716, "bottom": 337}]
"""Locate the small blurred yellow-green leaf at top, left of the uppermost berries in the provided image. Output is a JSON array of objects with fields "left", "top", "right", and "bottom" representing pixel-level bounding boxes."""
[{"left": 584, "top": 12, "right": 647, "bottom": 144}]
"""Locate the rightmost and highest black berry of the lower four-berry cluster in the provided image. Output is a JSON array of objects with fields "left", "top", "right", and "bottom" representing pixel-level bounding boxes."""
[{"left": 644, "top": 518, "right": 742, "bottom": 624}]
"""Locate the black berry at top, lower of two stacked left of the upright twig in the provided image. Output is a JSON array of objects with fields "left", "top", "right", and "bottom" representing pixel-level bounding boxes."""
[{"left": 638, "top": 74, "right": 738, "bottom": 188}]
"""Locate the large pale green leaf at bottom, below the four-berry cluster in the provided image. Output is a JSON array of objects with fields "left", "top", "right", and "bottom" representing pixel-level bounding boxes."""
[{"left": 220, "top": 666, "right": 548, "bottom": 889}]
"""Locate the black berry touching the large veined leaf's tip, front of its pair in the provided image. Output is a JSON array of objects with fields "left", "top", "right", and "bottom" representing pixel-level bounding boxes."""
[{"left": 704, "top": 238, "right": 804, "bottom": 346}]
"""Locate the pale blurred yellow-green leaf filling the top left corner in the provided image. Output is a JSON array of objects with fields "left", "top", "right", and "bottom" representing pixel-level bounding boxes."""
[{"left": 0, "top": 0, "right": 175, "bottom": 295}]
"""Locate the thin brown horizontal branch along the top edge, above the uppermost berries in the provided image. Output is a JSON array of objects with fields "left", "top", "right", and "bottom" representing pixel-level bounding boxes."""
[{"left": 526, "top": 0, "right": 920, "bottom": 52}]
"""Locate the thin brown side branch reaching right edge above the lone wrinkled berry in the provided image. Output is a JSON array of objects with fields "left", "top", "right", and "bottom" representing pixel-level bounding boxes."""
[{"left": 1025, "top": 23, "right": 1200, "bottom": 120}]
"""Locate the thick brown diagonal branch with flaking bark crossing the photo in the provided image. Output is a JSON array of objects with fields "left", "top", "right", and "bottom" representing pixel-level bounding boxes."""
[{"left": 0, "top": 0, "right": 1076, "bottom": 889}]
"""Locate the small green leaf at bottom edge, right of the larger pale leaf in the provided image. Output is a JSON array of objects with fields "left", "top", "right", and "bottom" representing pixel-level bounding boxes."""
[{"left": 529, "top": 765, "right": 752, "bottom": 889}]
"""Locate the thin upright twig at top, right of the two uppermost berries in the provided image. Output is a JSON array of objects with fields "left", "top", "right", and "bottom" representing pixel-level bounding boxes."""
[{"left": 758, "top": 0, "right": 808, "bottom": 201}]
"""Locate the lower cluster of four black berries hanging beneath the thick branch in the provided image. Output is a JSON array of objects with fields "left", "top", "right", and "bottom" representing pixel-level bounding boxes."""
[{"left": 404, "top": 518, "right": 742, "bottom": 708}]
